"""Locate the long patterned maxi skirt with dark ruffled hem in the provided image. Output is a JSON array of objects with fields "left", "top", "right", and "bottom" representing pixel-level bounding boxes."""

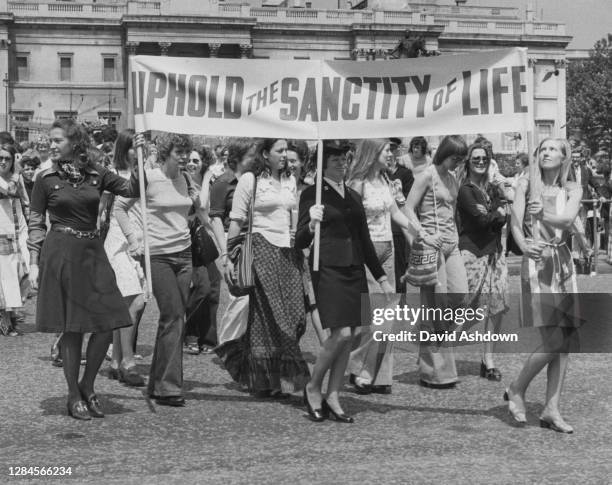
[{"left": 215, "top": 234, "right": 310, "bottom": 392}]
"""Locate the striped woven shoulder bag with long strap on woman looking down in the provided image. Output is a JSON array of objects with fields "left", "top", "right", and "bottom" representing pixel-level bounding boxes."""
[{"left": 403, "top": 168, "right": 440, "bottom": 286}]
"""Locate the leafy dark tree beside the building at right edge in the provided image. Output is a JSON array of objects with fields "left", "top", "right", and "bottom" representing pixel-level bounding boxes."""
[{"left": 567, "top": 34, "right": 612, "bottom": 151}]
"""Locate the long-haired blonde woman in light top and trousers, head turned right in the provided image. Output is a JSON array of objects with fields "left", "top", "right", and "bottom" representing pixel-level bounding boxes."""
[{"left": 347, "top": 139, "right": 410, "bottom": 394}]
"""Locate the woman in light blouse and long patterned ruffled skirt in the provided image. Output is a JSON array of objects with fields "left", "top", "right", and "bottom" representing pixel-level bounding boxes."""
[{"left": 216, "top": 139, "right": 310, "bottom": 398}]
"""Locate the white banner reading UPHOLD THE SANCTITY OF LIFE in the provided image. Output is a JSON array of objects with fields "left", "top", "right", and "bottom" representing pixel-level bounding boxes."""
[{"left": 129, "top": 48, "right": 533, "bottom": 139}]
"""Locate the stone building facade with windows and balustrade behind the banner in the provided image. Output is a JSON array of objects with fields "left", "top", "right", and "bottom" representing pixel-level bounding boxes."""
[{"left": 0, "top": 0, "right": 571, "bottom": 151}]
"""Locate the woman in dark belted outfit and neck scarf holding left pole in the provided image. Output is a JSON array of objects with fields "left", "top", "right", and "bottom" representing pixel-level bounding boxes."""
[{"left": 28, "top": 120, "right": 139, "bottom": 420}]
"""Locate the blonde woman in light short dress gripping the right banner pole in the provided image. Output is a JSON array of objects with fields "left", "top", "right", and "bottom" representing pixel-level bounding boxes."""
[{"left": 504, "top": 138, "right": 582, "bottom": 433}]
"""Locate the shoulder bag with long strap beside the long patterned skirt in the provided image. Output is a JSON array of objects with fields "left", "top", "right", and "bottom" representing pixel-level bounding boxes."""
[{"left": 227, "top": 177, "right": 257, "bottom": 296}]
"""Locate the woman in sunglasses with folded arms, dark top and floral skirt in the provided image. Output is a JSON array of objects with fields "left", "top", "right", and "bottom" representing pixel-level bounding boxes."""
[{"left": 457, "top": 143, "right": 508, "bottom": 381}]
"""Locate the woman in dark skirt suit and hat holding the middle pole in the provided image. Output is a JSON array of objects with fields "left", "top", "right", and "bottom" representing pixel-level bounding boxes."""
[{"left": 295, "top": 141, "right": 393, "bottom": 423}]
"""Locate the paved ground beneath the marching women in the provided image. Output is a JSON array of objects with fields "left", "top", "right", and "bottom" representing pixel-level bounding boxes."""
[{"left": 0, "top": 261, "right": 612, "bottom": 484}]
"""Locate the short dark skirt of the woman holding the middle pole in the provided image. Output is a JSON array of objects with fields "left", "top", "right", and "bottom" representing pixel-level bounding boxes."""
[{"left": 312, "top": 266, "right": 368, "bottom": 328}]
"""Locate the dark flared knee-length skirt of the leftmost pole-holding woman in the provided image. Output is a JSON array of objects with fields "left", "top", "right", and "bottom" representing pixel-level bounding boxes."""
[{"left": 36, "top": 231, "right": 132, "bottom": 333}]
